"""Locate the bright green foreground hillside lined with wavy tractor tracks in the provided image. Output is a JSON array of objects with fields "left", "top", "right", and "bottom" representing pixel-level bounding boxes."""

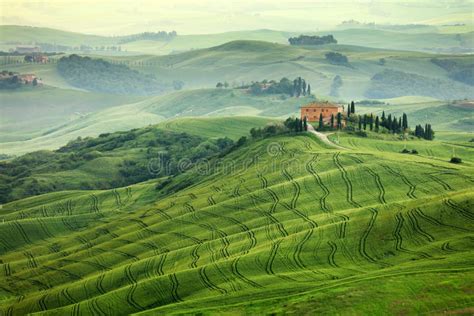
[{"left": 0, "top": 131, "right": 474, "bottom": 315}]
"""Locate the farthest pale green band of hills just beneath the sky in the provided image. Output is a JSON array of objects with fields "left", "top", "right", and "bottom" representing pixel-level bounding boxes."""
[{"left": 0, "top": 25, "right": 474, "bottom": 55}]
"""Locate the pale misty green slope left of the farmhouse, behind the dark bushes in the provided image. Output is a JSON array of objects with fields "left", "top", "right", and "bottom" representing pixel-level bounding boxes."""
[{"left": 0, "top": 89, "right": 311, "bottom": 155}]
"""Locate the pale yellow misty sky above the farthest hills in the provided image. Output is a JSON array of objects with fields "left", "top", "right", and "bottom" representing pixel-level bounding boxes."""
[{"left": 0, "top": 0, "right": 474, "bottom": 35}]
